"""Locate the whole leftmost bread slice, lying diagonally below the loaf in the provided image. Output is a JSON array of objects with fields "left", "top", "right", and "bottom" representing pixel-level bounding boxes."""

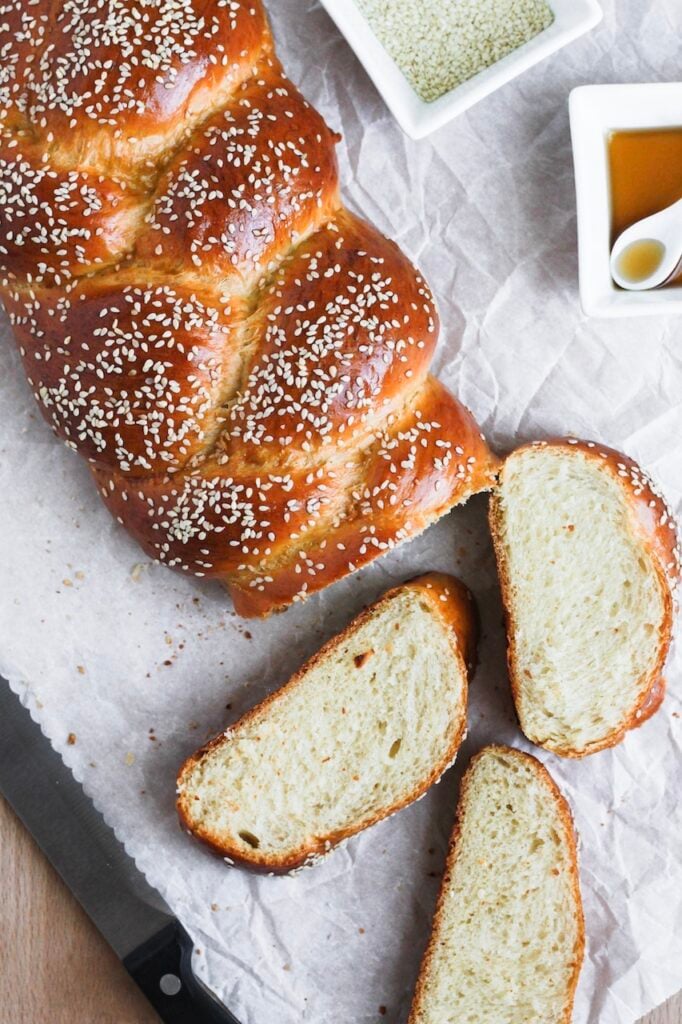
[{"left": 177, "top": 573, "right": 476, "bottom": 872}]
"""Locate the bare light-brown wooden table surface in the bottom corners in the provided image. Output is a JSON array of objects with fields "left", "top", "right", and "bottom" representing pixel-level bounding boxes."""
[{"left": 0, "top": 800, "right": 682, "bottom": 1024}]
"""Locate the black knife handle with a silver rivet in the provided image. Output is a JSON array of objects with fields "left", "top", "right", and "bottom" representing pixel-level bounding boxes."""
[{"left": 123, "top": 921, "right": 239, "bottom": 1024}]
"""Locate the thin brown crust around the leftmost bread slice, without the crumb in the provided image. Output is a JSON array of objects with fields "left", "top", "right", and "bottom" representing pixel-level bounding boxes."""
[{"left": 177, "top": 572, "right": 478, "bottom": 874}]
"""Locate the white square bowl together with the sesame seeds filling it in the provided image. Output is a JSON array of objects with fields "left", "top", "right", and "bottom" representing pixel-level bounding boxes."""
[{"left": 321, "top": 0, "right": 602, "bottom": 138}]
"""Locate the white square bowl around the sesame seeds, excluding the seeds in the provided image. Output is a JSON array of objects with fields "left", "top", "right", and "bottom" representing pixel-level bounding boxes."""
[{"left": 321, "top": 0, "right": 602, "bottom": 138}]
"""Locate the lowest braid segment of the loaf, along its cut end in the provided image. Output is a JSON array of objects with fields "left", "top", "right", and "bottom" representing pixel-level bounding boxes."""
[{"left": 227, "top": 377, "right": 498, "bottom": 617}]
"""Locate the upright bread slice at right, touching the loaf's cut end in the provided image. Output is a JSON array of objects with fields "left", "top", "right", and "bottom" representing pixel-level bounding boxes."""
[{"left": 491, "top": 438, "right": 679, "bottom": 758}]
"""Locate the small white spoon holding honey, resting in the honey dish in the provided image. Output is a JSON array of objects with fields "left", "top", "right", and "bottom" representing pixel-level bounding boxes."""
[{"left": 610, "top": 200, "right": 682, "bottom": 292}]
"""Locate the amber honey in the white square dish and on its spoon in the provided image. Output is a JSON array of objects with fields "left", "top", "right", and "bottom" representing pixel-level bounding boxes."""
[{"left": 608, "top": 127, "right": 682, "bottom": 287}]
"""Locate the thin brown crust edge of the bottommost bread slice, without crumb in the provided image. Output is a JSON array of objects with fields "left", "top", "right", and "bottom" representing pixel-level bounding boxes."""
[{"left": 408, "top": 743, "right": 585, "bottom": 1024}]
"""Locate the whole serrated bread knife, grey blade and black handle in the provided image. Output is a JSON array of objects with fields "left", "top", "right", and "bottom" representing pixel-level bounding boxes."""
[{"left": 0, "top": 677, "right": 239, "bottom": 1024}]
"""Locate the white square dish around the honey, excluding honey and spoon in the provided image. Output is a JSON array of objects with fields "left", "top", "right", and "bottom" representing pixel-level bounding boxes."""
[{"left": 568, "top": 82, "right": 682, "bottom": 317}]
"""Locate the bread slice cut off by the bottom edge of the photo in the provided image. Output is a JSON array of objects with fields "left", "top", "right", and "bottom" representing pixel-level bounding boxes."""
[{"left": 409, "top": 746, "right": 585, "bottom": 1024}]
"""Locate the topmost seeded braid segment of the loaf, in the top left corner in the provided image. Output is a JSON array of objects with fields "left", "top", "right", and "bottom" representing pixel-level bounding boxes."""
[{"left": 0, "top": 0, "right": 272, "bottom": 173}]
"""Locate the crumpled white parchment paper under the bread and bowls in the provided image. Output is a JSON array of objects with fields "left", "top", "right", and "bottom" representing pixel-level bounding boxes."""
[{"left": 0, "top": 0, "right": 682, "bottom": 1024}]
